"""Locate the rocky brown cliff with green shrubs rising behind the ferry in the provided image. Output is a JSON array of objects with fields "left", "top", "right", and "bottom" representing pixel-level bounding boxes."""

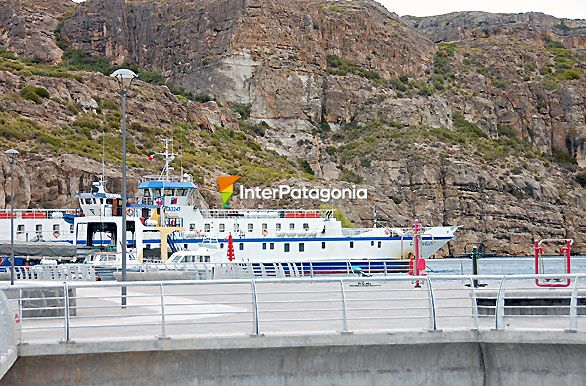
[{"left": 0, "top": 0, "right": 586, "bottom": 253}]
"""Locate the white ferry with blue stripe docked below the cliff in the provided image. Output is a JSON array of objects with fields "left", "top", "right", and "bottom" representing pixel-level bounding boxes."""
[{"left": 0, "top": 141, "right": 458, "bottom": 271}]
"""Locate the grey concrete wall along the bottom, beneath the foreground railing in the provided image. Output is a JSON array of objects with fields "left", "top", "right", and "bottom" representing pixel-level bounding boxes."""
[{"left": 1, "top": 332, "right": 586, "bottom": 386}]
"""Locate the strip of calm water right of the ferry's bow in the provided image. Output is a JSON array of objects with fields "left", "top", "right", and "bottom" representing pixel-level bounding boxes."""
[{"left": 427, "top": 256, "right": 586, "bottom": 275}]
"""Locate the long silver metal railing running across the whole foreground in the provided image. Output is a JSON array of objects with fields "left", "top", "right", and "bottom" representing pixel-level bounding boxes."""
[{"left": 3, "top": 275, "right": 586, "bottom": 343}]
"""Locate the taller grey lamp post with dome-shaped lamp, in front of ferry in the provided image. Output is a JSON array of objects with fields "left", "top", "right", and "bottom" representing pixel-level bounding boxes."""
[{"left": 110, "top": 69, "right": 137, "bottom": 307}]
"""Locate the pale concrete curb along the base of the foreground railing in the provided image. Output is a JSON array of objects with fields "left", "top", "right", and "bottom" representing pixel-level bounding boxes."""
[{"left": 18, "top": 330, "right": 586, "bottom": 356}]
